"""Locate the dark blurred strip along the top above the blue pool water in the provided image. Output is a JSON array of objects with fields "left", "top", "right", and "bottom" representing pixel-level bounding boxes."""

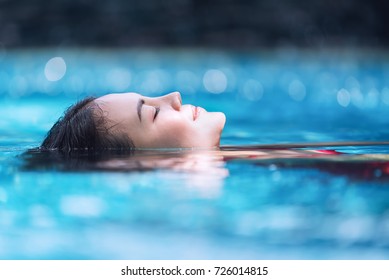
[{"left": 0, "top": 0, "right": 389, "bottom": 49}]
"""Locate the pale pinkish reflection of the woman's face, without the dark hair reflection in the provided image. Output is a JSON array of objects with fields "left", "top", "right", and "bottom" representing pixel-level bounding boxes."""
[{"left": 97, "top": 151, "right": 229, "bottom": 198}]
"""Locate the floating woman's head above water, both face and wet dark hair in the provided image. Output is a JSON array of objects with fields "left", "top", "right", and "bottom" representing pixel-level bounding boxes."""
[{"left": 41, "top": 92, "right": 226, "bottom": 151}]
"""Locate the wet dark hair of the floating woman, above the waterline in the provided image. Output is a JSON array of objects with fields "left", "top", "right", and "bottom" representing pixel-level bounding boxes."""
[{"left": 39, "top": 97, "right": 134, "bottom": 152}]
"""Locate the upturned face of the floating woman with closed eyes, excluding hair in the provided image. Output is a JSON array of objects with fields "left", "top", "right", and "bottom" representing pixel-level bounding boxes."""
[{"left": 95, "top": 92, "right": 226, "bottom": 148}]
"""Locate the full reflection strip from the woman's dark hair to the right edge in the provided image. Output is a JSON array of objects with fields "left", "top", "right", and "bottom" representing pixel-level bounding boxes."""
[{"left": 21, "top": 146, "right": 389, "bottom": 197}]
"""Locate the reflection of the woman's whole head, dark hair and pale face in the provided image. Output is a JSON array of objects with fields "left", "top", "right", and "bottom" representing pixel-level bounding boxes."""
[{"left": 21, "top": 149, "right": 229, "bottom": 198}]
